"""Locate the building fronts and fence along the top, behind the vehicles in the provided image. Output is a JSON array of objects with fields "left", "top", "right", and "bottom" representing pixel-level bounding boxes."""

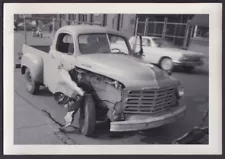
[{"left": 15, "top": 14, "right": 209, "bottom": 51}]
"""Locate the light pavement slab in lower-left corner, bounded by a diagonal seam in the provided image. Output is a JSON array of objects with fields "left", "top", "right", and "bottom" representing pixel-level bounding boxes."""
[{"left": 14, "top": 92, "right": 63, "bottom": 145}]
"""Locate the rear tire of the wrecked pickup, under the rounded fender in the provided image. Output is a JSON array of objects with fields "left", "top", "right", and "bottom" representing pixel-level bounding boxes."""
[{"left": 24, "top": 68, "right": 40, "bottom": 94}]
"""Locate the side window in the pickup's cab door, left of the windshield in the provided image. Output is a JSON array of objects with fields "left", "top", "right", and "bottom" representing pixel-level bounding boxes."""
[{"left": 56, "top": 33, "right": 74, "bottom": 55}]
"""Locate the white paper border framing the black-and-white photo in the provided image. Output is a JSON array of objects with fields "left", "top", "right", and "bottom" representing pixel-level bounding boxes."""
[{"left": 3, "top": 3, "right": 222, "bottom": 155}]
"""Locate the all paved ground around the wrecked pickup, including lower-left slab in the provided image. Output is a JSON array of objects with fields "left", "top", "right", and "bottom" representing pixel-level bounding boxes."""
[{"left": 14, "top": 33, "right": 209, "bottom": 144}]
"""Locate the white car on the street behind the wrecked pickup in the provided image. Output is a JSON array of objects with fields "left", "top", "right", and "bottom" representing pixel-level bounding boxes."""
[{"left": 129, "top": 36, "right": 204, "bottom": 72}]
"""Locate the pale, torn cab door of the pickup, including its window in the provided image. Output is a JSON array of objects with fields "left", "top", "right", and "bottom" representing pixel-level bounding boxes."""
[{"left": 44, "top": 33, "right": 82, "bottom": 96}]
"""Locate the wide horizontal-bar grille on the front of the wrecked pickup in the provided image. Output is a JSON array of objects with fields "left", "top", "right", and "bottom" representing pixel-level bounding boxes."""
[{"left": 124, "top": 87, "right": 176, "bottom": 114}]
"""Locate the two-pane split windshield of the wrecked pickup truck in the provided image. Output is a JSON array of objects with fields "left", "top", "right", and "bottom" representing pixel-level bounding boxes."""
[{"left": 78, "top": 33, "right": 129, "bottom": 54}]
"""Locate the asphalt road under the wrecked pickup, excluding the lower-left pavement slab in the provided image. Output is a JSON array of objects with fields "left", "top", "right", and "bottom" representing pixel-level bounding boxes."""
[{"left": 14, "top": 31, "right": 209, "bottom": 144}]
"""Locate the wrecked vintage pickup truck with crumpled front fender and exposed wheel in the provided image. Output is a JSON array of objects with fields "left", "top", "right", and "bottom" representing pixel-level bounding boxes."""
[{"left": 21, "top": 25, "right": 186, "bottom": 136}]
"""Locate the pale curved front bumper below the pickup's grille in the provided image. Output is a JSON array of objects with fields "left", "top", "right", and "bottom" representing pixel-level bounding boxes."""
[{"left": 110, "top": 106, "right": 186, "bottom": 132}]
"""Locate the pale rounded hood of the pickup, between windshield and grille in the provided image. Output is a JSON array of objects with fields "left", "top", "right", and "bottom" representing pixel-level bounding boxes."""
[{"left": 76, "top": 54, "right": 176, "bottom": 88}]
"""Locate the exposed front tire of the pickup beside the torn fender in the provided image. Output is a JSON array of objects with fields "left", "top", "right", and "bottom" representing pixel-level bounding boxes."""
[{"left": 79, "top": 94, "right": 96, "bottom": 136}]
